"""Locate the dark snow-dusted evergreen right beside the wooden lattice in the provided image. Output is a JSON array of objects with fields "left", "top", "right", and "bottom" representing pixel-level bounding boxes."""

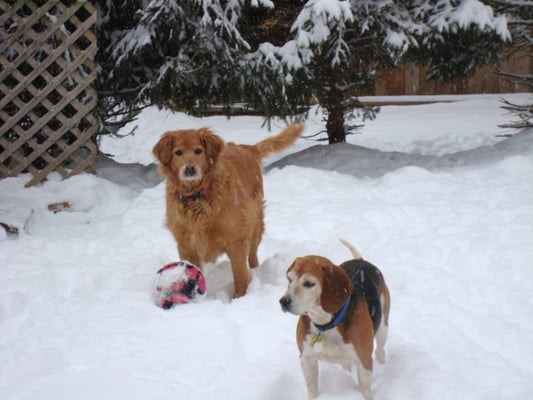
[{"left": 96, "top": 0, "right": 294, "bottom": 134}]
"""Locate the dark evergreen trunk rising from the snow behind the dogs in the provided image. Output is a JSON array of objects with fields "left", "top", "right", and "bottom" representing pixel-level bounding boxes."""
[{"left": 326, "top": 66, "right": 346, "bottom": 144}]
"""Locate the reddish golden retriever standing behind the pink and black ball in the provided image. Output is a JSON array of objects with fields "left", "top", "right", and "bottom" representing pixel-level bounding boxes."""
[{"left": 153, "top": 125, "right": 303, "bottom": 297}]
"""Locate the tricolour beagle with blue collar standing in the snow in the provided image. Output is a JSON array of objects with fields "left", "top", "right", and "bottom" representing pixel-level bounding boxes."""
[{"left": 279, "top": 239, "right": 390, "bottom": 400}]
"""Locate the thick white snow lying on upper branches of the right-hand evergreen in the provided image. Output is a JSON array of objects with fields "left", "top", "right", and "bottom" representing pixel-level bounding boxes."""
[{"left": 268, "top": 0, "right": 511, "bottom": 69}]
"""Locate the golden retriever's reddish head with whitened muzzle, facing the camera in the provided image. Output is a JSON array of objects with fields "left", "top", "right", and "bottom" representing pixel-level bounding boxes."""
[{"left": 152, "top": 128, "right": 224, "bottom": 193}]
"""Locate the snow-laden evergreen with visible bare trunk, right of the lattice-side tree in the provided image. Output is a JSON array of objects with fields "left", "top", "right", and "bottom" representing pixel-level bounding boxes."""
[{"left": 251, "top": 0, "right": 509, "bottom": 143}]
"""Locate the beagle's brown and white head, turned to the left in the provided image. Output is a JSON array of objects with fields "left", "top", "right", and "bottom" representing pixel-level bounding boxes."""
[{"left": 279, "top": 256, "right": 352, "bottom": 323}]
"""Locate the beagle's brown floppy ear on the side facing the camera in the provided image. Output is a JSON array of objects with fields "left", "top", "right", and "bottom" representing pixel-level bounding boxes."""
[{"left": 320, "top": 263, "right": 352, "bottom": 314}]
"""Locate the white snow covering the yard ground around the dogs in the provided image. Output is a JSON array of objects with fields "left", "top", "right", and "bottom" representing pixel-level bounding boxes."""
[{"left": 0, "top": 94, "right": 533, "bottom": 400}]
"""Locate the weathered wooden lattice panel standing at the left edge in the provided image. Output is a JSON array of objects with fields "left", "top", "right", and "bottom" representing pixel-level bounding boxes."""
[{"left": 0, "top": 0, "right": 97, "bottom": 186}]
